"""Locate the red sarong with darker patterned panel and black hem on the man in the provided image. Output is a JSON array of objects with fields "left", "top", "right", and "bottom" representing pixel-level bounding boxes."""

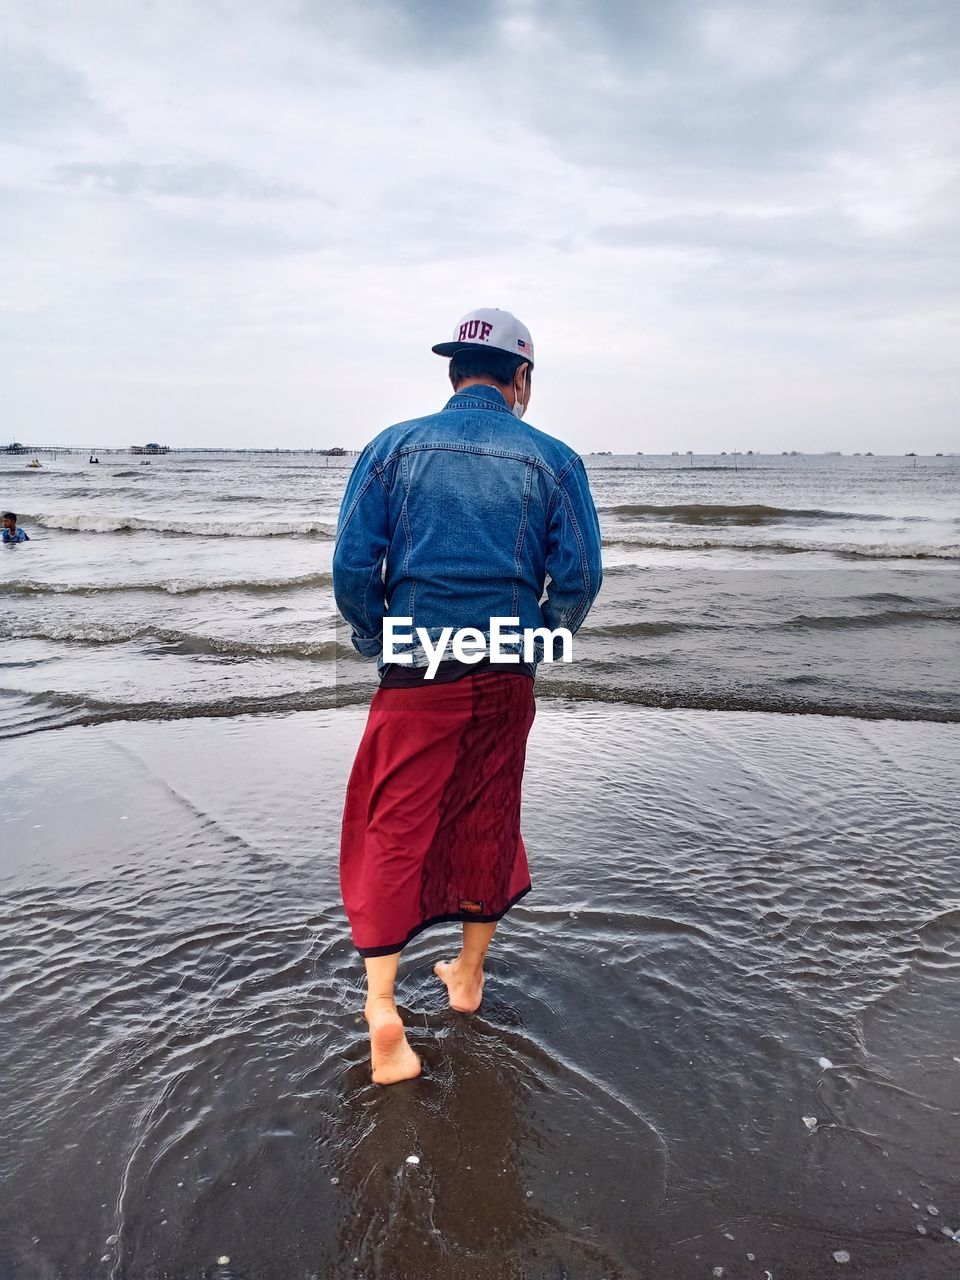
[{"left": 340, "top": 671, "right": 535, "bottom": 956}]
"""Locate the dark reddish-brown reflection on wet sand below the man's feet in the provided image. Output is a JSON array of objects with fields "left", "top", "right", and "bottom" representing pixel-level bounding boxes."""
[{"left": 339, "top": 1011, "right": 531, "bottom": 1277}]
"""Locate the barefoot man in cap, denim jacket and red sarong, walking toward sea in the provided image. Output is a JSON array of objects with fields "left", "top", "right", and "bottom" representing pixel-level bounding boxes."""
[{"left": 333, "top": 308, "right": 602, "bottom": 1084}]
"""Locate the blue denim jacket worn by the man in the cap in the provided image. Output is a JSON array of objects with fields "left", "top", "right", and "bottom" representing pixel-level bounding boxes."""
[{"left": 333, "top": 385, "right": 602, "bottom": 666}]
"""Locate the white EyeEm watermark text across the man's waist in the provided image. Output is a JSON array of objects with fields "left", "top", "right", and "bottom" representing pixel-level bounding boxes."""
[{"left": 383, "top": 617, "right": 573, "bottom": 680}]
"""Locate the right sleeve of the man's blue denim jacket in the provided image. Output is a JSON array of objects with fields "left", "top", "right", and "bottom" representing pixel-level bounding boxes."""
[{"left": 540, "top": 457, "right": 603, "bottom": 634}]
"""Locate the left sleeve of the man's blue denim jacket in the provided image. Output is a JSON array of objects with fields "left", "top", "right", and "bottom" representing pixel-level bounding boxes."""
[{"left": 333, "top": 444, "right": 390, "bottom": 658}]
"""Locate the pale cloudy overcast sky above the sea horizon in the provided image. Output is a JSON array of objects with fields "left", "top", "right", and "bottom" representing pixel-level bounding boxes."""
[{"left": 0, "top": 0, "right": 960, "bottom": 453}]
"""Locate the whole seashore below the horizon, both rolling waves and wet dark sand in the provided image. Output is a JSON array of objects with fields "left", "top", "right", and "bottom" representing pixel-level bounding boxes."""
[{"left": 0, "top": 454, "right": 960, "bottom": 1280}]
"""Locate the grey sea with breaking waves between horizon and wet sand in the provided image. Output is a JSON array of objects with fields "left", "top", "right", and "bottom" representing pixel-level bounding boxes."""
[{"left": 0, "top": 454, "right": 960, "bottom": 736}]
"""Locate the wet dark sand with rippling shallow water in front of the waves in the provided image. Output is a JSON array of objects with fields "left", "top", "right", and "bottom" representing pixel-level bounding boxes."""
[{"left": 0, "top": 700, "right": 960, "bottom": 1280}]
